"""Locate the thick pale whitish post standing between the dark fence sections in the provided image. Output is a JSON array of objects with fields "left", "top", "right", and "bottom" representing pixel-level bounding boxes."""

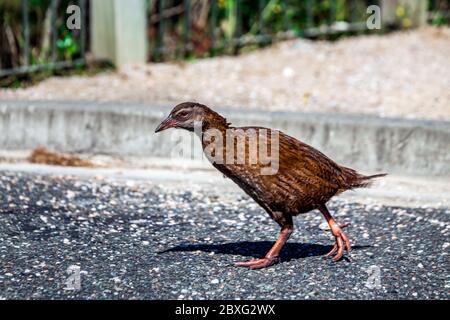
[{"left": 91, "top": 0, "right": 147, "bottom": 69}]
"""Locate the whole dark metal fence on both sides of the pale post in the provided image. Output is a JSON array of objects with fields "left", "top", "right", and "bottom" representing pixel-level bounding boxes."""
[{"left": 0, "top": 0, "right": 450, "bottom": 77}]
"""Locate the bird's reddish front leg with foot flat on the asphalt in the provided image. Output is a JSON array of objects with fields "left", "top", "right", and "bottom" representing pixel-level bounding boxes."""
[{"left": 235, "top": 217, "right": 294, "bottom": 269}]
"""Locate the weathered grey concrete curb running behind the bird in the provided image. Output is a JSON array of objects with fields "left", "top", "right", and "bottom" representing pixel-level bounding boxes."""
[{"left": 0, "top": 101, "right": 450, "bottom": 176}]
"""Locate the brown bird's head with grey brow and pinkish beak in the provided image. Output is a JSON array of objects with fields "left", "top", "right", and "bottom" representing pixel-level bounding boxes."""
[{"left": 155, "top": 102, "right": 232, "bottom": 132}]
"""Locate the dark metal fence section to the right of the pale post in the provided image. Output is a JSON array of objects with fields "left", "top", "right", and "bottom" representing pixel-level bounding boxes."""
[{"left": 149, "top": 0, "right": 381, "bottom": 60}]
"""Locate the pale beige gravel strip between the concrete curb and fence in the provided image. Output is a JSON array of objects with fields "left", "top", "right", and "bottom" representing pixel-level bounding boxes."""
[{"left": 0, "top": 27, "right": 450, "bottom": 120}]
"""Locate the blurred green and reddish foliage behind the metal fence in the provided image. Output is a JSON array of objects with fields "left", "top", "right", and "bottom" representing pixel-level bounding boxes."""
[{"left": 0, "top": 0, "right": 450, "bottom": 85}]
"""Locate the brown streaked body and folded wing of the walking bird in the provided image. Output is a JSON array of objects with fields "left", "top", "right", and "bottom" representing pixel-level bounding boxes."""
[{"left": 209, "top": 127, "right": 354, "bottom": 212}]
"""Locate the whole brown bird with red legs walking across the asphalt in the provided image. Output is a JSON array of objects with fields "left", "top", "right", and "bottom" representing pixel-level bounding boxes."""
[{"left": 155, "top": 102, "right": 386, "bottom": 269}]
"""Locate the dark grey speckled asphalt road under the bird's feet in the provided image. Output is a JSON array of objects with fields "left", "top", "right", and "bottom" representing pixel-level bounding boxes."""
[{"left": 0, "top": 172, "right": 450, "bottom": 299}]
